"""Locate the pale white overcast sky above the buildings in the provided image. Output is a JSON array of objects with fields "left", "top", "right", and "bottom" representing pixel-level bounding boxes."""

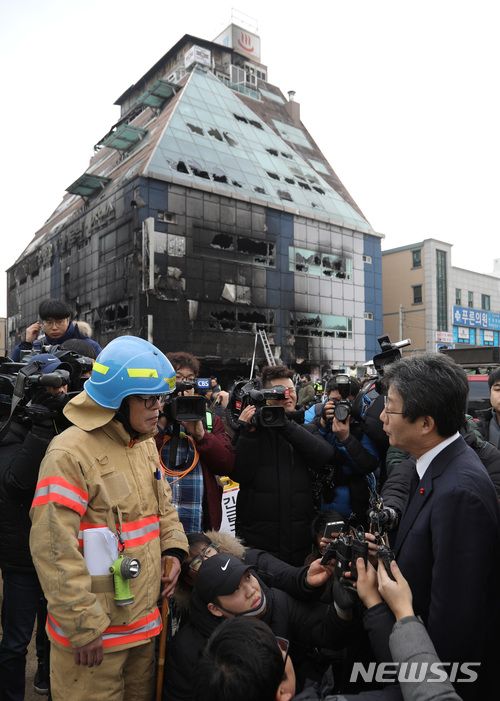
[{"left": 0, "top": 0, "right": 500, "bottom": 316}]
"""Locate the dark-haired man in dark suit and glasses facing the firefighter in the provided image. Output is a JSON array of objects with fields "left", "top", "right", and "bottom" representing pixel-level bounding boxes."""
[{"left": 380, "top": 353, "right": 500, "bottom": 699}]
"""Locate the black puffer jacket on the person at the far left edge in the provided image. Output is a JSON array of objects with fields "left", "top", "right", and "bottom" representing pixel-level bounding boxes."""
[{"left": 0, "top": 421, "right": 51, "bottom": 572}]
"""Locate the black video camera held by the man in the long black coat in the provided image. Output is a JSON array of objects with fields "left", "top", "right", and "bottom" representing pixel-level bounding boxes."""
[{"left": 226, "top": 380, "right": 290, "bottom": 430}]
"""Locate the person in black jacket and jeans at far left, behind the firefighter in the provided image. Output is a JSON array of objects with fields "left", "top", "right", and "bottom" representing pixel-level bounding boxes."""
[{"left": 0, "top": 354, "right": 69, "bottom": 701}]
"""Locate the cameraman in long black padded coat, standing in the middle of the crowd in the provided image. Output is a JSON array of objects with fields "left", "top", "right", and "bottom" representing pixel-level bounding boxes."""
[{"left": 231, "top": 365, "right": 333, "bottom": 566}]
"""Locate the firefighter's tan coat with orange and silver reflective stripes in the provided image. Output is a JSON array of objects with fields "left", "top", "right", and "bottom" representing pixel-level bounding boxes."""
[{"left": 30, "top": 392, "right": 188, "bottom": 652}]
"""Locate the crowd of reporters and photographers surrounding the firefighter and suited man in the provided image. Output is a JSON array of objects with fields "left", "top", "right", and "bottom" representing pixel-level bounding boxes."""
[{"left": 0, "top": 300, "right": 500, "bottom": 701}]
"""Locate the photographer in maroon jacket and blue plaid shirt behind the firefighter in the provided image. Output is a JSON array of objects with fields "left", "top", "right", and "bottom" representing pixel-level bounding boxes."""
[{"left": 156, "top": 352, "right": 234, "bottom": 533}]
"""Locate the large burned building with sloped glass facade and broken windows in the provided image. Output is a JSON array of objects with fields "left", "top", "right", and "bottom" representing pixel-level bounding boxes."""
[{"left": 7, "top": 25, "right": 382, "bottom": 376}]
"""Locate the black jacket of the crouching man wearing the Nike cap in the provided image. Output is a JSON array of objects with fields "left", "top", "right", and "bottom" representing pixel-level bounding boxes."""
[{"left": 162, "top": 579, "right": 362, "bottom": 701}]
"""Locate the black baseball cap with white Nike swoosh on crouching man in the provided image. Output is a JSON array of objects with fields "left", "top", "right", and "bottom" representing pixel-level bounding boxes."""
[{"left": 194, "top": 553, "right": 253, "bottom": 604}]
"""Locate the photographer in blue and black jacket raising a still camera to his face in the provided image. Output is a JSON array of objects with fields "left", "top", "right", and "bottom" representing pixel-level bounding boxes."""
[{"left": 306, "top": 375, "right": 379, "bottom": 523}]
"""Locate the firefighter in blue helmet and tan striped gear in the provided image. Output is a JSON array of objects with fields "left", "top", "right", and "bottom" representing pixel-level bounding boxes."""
[{"left": 30, "top": 336, "right": 188, "bottom": 701}]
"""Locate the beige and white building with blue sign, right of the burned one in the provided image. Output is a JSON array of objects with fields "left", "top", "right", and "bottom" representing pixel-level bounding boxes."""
[{"left": 382, "top": 238, "right": 500, "bottom": 353}]
